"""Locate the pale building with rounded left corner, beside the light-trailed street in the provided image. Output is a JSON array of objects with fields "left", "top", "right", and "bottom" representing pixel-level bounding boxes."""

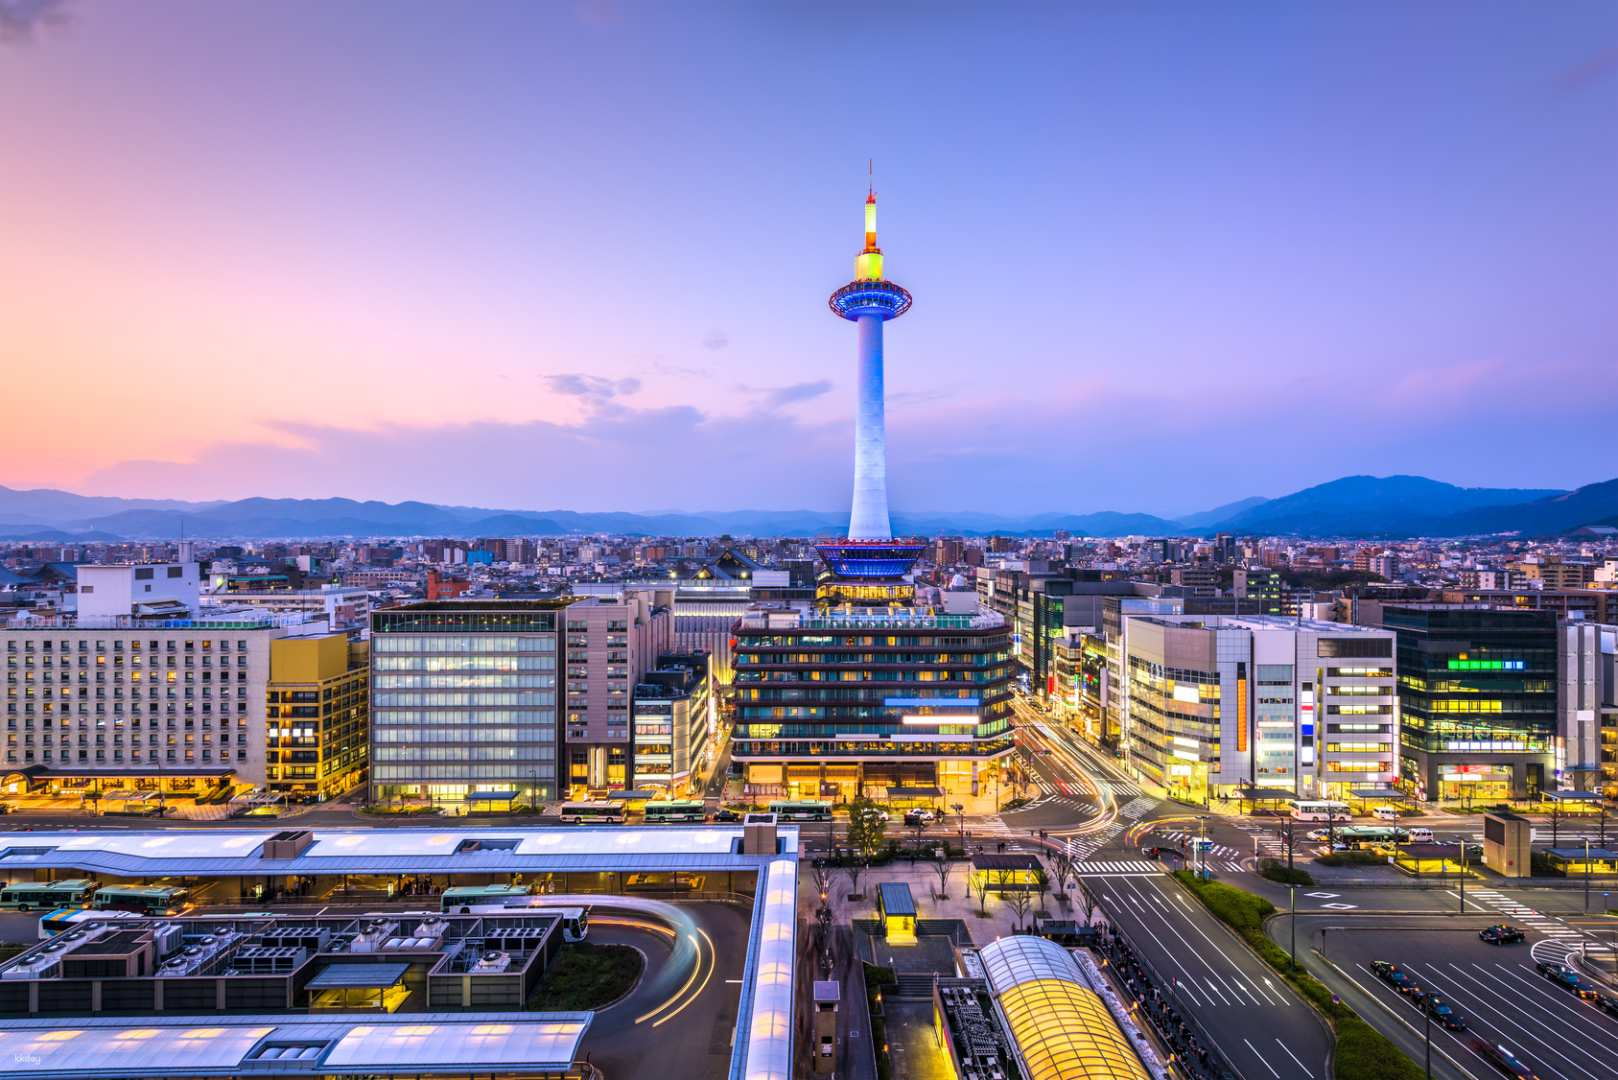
[{"left": 1123, "top": 615, "right": 1398, "bottom": 805}]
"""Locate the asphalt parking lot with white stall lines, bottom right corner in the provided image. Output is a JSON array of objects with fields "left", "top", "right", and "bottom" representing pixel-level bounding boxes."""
[{"left": 1299, "top": 918, "right": 1618, "bottom": 1080}]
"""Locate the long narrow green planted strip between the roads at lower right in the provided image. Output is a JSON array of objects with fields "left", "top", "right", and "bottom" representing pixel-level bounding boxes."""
[{"left": 1173, "top": 870, "right": 1424, "bottom": 1080}]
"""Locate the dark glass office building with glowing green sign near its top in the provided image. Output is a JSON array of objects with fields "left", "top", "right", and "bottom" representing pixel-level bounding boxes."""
[{"left": 1382, "top": 604, "right": 1558, "bottom": 801}]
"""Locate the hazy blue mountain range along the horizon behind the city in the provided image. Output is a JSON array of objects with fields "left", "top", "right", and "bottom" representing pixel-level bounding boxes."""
[{"left": 0, "top": 476, "right": 1618, "bottom": 542}]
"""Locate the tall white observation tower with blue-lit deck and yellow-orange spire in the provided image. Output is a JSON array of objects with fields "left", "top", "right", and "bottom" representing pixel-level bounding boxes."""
[{"left": 817, "top": 180, "right": 922, "bottom": 601}]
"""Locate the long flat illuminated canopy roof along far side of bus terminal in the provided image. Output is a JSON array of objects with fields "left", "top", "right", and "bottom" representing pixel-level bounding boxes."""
[{"left": 0, "top": 824, "right": 798, "bottom": 878}]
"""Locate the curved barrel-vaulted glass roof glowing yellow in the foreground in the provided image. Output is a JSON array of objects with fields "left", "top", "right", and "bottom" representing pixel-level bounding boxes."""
[{"left": 977, "top": 934, "right": 1150, "bottom": 1080}]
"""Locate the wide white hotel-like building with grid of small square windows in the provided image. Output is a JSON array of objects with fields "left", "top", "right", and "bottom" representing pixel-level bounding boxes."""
[{"left": 0, "top": 563, "right": 327, "bottom": 797}]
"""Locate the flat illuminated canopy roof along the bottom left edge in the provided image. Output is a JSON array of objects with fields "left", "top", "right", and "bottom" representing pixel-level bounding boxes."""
[{"left": 0, "top": 1012, "right": 591, "bottom": 1080}]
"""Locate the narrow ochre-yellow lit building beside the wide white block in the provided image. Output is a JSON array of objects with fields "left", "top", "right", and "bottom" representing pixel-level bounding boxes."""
[{"left": 264, "top": 633, "right": 371, "bottom": 800}]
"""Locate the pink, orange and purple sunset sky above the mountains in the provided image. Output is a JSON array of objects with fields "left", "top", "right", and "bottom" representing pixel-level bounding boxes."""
[{"left": 0, "top": 0, "right": 1618, "bottom": 513}]
